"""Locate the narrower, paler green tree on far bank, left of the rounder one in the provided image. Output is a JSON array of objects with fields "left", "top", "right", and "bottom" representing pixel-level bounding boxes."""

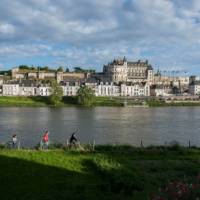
[{"left": 49, "top": 81, "right": 63, "bottom": 106}]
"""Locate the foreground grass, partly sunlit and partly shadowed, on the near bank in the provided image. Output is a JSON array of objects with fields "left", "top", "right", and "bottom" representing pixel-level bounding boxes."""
[{"left": 0, "top": 146, "right": 200, "bottom": 200}]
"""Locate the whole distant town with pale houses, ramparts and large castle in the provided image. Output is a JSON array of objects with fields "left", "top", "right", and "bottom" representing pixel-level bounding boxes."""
[{"left": 0, "top": 57, "right": 200, "bottom": 100}]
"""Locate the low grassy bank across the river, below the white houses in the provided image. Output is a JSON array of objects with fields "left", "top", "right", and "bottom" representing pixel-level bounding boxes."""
[{"left": 0, "top": 96, "right": 200, "bottom": 107}]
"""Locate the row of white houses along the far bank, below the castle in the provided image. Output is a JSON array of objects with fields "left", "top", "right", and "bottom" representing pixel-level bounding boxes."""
[{"left": 3, "top": 82, "right": 150, "bottom": 97}]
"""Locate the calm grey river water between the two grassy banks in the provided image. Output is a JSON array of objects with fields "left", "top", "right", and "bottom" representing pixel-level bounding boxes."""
[{"left": 0, "top": 107, "right": 200, "bottom": 147}]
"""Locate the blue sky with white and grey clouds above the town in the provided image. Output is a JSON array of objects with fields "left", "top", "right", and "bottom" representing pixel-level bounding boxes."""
[{"left": 0, "top": 0, "right": 200, "bottom": 75}]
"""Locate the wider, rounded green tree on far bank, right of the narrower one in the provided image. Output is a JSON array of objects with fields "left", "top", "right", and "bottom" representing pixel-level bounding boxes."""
[{"left": 77, "top": 86, "right": 94, "bottom": 106}]
